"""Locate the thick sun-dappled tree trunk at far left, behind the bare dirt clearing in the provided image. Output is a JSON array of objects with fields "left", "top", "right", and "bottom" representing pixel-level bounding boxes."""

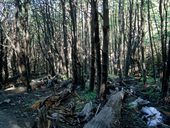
[{"left": 15, "top": 0, "right": 31, "bottom": 90}]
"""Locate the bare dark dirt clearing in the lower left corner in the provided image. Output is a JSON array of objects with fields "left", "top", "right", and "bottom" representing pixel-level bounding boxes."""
[{"left": 0, "top": 86, "right": 51, "bottom": 128}]
